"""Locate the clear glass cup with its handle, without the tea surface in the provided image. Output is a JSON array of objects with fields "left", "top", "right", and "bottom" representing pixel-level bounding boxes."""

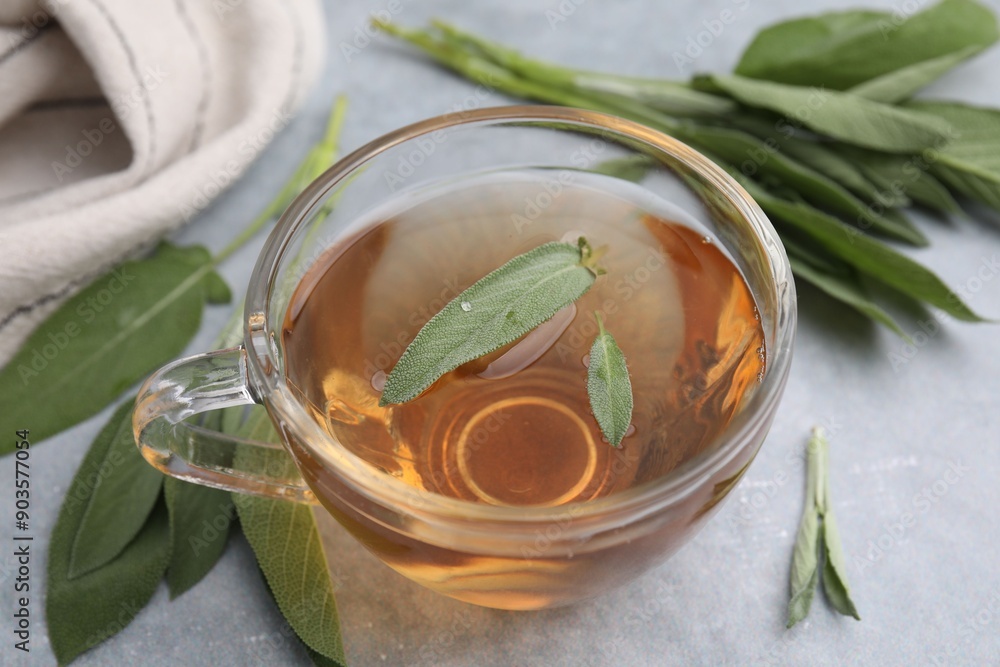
[{"left": 134, "top": 106, "right": 795, "bottom": 609}]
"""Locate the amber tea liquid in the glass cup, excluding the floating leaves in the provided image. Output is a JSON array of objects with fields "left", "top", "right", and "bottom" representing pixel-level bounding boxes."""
[{"left": 283, "top": 171, "right": 765, "bottom": 609}]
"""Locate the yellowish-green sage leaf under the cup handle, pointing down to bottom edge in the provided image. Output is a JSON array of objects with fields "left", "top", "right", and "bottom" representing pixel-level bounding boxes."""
[{"left": 232, "top": 407, "right": 346, "bottom": 664}]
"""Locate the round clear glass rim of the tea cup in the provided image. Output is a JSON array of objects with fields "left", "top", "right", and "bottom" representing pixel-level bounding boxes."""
[{"left": 244, "top": 105, "right": 796, "bottom": 525}]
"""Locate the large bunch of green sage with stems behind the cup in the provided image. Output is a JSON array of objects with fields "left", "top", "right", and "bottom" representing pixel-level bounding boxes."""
[{"left": 376, "top": 0, "right": 1000, "bottom": 335}]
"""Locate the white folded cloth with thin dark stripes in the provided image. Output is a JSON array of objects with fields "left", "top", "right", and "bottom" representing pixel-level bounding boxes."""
[{"left": 0, "top": 0, "right": 325, "bottom": 364}]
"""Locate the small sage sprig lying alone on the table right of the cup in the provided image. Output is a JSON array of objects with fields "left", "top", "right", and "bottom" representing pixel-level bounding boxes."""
[{"left": 787, "top": 428, "right": 861, "bottom": 628}]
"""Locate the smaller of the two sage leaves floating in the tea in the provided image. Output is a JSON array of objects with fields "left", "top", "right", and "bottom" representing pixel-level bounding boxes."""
[{"left": 587, "top": 313, "right": 632, "bottom": 447}]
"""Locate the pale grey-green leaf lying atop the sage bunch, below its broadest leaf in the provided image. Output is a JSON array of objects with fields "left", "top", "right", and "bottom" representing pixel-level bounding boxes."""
[{"left": 695, "top": 75, "right": 954, "bottom": 153}]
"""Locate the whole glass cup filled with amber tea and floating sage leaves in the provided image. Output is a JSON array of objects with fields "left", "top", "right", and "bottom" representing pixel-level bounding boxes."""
[{"left": 135, "top": 107, "right": 794, "bottom": 609}]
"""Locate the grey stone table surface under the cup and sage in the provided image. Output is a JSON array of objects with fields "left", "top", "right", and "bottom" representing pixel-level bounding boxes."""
[{"left": 0, "top": 0, "right": 1000, "bottom": 667}]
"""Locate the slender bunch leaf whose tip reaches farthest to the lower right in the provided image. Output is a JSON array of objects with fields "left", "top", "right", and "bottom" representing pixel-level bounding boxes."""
[{"left": 730, "top": 172, "right": 984, "bottom": 322}]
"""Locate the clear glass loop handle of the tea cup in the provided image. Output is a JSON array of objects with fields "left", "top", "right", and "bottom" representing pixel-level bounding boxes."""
[{"left": 132, "top": 346, "right": 316, "bottom": 503}]
